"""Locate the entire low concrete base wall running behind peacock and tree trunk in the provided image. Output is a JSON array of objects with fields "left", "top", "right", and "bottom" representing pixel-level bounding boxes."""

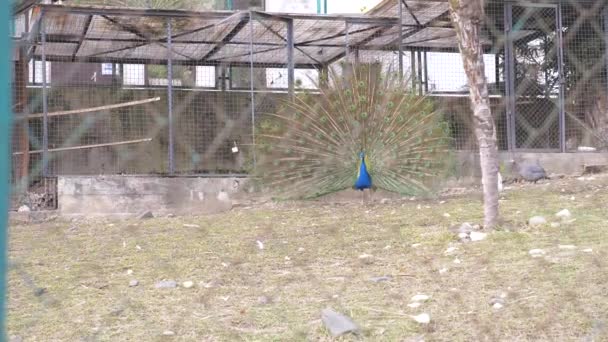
[{"left": 58, "top": 152, "right": 608, "bottom": 216}]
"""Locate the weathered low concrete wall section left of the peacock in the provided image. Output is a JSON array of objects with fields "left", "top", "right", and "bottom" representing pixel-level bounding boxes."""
[{"left": 57, "top": 176, "right": 246, "bottom": 216}]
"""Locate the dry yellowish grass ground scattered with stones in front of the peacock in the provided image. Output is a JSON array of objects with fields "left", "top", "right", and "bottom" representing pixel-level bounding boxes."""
[{"left": 8, "top": 178, "right": 608, "bottom": 341}]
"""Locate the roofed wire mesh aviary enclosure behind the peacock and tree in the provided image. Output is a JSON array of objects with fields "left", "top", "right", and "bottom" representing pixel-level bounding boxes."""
[{"left": 12, "top": 0, "right": 608, "bottom": 206}]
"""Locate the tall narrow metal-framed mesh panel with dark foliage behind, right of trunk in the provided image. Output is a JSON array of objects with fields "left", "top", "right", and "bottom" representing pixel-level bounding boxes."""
[{"left": 511, "top": 6, "right": 561, "bottom": 149}]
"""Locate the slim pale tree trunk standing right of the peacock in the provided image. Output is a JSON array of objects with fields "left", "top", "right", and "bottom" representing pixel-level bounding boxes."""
[{"left": 449, "top": 0, "right": 498, "bottom": 228}]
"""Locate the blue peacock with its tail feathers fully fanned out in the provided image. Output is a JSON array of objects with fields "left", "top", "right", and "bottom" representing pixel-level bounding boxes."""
[{"left": 254, "top": 63, "right": 450, "bottom": 198}]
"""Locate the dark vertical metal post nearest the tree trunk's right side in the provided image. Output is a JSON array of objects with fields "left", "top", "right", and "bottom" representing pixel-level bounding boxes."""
[{"left": 504, "top": 3, "right": 517, "bottom": 151}]
